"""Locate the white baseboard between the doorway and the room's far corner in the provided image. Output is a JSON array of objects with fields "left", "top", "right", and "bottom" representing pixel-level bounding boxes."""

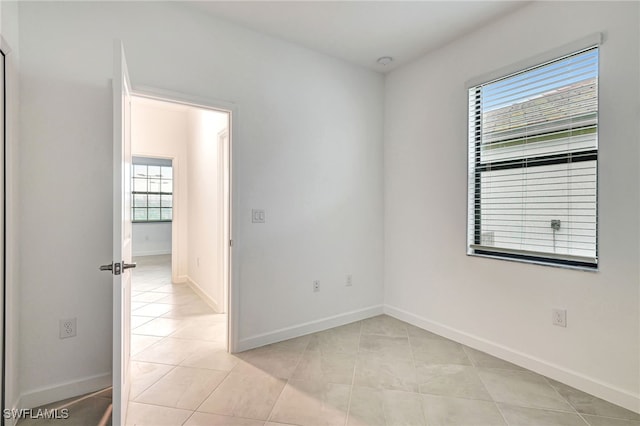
[{"left": 237, "top": 305, "right": 383, "bottom": 352}]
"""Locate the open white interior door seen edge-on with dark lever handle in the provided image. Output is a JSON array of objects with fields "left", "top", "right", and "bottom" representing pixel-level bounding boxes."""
[{"left": 112, "top": 40, "right": 135, "bottom": 425}]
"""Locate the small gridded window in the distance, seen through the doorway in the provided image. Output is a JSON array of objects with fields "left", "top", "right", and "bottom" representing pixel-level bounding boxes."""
[{"left": 131, "top": 157, "right": 173, "bottom": 222}]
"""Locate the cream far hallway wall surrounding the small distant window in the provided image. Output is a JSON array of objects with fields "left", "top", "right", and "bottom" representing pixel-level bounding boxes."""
[{"left": 131, "top": 97, "right": 188, "bottom": 283}]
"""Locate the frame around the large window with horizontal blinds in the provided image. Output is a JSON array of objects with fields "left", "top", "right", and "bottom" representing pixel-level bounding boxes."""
[{"left": 466, "top": 33, "right": 602, "bottom": 271}]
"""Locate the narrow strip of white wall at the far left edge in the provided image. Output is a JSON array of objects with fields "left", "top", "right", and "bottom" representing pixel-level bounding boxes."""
[{"left": 0, "top": 2, "right": 21, "bottom": 418}]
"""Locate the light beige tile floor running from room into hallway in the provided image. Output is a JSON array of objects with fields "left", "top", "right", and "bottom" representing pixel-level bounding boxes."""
[{"left": 21, "top": 256, "right": 640, "bottom": 426}]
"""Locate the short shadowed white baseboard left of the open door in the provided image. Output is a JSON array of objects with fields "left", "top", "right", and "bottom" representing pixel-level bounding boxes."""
[{"left": 17, "top": 373, "right": 112, "bottom": 408}]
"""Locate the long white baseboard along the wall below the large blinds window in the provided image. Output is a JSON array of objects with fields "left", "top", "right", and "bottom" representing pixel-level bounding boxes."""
[{"left": 384, "top": 305, "right": 640, "bottom": 413}]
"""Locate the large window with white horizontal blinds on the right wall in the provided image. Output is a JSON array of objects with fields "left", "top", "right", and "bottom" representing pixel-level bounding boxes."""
[{"left": 468, "top": 47, "right": 598, "bottom": 268}]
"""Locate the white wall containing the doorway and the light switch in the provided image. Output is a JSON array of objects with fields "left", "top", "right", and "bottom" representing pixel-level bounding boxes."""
[{"left": 18, "top": 2, "right": 384, "bottom": 402}]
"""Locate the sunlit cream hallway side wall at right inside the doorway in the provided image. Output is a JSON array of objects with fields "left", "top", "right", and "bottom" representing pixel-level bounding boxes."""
[{"left": 187, "top": 109, "right": 229, "bottom": 312}]
